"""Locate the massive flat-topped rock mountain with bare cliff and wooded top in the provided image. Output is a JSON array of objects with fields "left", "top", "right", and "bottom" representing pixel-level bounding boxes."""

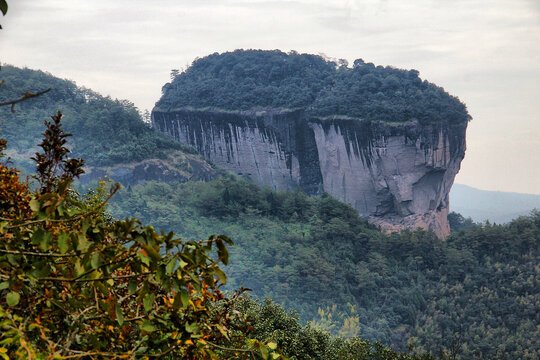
[{"left": 152, "top": 50, "right": 470, "bottom": 237}]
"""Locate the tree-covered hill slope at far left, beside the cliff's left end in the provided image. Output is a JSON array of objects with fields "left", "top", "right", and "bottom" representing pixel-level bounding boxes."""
[{"left": 0, "top": 65, "right": 192, "bottom": 167}]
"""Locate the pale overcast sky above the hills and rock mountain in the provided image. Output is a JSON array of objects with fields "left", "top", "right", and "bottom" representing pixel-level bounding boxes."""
[{"left": 0, "top": 0, "right": 540, "bottom": 194}]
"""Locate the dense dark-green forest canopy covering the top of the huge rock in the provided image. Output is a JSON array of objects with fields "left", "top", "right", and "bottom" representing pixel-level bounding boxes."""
[{"left": 156, "top": 50, "right": 470, "bottom": 123}]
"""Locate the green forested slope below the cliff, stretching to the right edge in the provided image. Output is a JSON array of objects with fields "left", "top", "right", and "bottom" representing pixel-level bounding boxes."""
[{"left": 109, "top": 179, "right": 540, "bottom": 359}]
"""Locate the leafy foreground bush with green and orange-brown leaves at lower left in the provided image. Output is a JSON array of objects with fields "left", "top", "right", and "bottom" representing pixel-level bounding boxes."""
[{"left": 0, "top": 113, "right": 284, "bottom": 359}]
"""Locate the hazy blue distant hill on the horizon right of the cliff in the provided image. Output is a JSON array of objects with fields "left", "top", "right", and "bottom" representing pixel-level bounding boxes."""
[{"left": 450, "top": 184, "right": 540, "bottom": 223}]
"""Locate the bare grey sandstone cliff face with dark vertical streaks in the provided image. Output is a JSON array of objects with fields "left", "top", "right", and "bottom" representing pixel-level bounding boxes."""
[{"left": 152, "top": 110, "right": 467, "bottom": 237}]
